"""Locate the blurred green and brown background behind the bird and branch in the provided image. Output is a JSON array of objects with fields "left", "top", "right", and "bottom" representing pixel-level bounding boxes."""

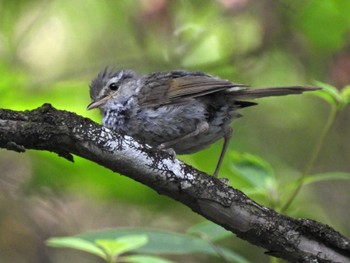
[{"left": 0, "top": 0, "right": 350, "bottom": 262}]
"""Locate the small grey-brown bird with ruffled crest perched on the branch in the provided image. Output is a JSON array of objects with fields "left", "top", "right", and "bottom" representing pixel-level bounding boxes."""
[{"left": 87, "top": 68, "right": 318, "bottom": 177}]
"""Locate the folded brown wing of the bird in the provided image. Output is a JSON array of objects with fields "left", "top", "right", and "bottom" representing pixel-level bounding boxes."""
[{"left": 139, "top": 71, "right": 246, "bottom": 107}]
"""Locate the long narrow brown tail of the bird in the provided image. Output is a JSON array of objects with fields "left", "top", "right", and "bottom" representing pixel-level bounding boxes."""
[{"left": 230, "top": 86, "right": 321, "bottom": 99}]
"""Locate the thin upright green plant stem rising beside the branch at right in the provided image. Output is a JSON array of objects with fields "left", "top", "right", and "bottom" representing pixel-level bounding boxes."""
[{"left": 281, "top": 106, "right": 339, "bottom": 213}]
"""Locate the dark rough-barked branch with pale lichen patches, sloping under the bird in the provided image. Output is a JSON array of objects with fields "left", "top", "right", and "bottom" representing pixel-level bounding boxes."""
[{"left": 0, "top": 104, "right": 350, "bottom": 262}]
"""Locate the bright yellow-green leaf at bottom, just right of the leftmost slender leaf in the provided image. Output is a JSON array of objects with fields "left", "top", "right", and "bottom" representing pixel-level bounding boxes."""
[{"left": 95, "top": 235, "right": 147, "bottom": 258}]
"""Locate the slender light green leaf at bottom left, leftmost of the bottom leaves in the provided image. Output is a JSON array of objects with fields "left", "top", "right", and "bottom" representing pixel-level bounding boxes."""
[{"left": 46, "top": 237, "right": 107, "bottom": 260}]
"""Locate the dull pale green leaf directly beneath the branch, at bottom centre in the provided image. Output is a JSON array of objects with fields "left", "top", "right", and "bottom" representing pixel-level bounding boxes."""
[{"left": 187, "top": 221, "right": 232, "bottom": 242}]
